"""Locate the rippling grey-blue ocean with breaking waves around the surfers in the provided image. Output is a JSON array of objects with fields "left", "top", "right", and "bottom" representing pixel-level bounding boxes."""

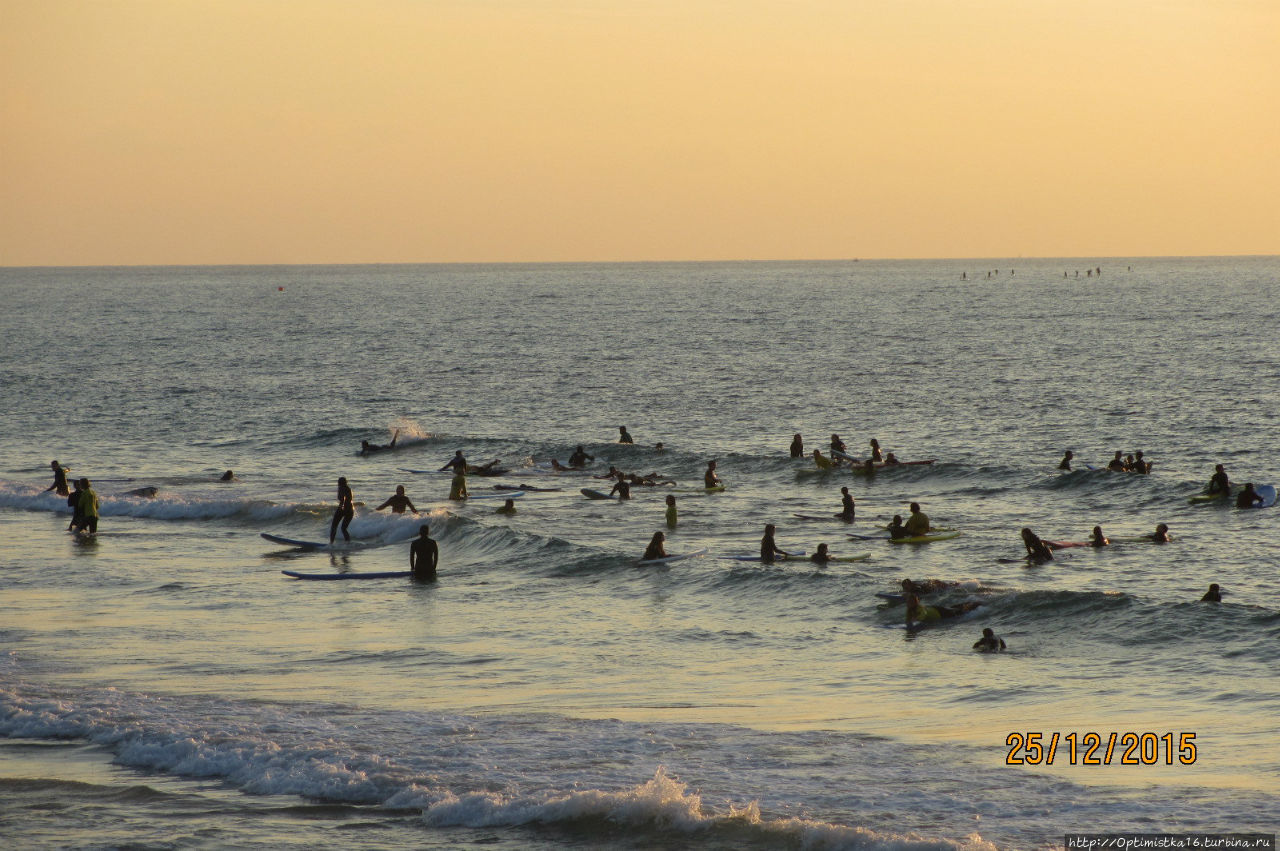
[{"left": 0, "top": 257, "right": 1280, "bottom": 850}]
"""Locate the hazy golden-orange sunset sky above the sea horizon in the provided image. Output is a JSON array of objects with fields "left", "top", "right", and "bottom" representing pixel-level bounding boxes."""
[{"left": 0, "top": 0, "right": 1280, "bottom": 266}]
